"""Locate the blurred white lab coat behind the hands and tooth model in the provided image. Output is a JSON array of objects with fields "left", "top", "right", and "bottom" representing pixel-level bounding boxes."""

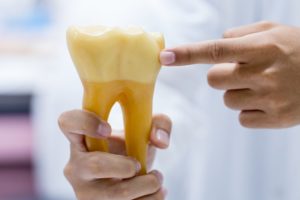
[{"left": 34, "top": 0, "right": 300, "bottom": 200}]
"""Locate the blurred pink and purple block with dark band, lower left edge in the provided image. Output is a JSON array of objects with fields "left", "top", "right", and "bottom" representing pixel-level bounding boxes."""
[{"left": 0, "top": 115, "right": 34, "bottom": 200}]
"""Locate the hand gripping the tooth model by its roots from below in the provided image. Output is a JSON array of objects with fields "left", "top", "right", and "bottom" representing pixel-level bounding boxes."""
[{"left": 59, "top": 110, "right": 171, "bottom": 200}]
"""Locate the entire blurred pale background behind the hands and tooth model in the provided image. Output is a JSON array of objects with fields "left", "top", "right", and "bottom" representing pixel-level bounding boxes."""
[{"left": 0, "top": 0, "right": 300, "bottom": 200}]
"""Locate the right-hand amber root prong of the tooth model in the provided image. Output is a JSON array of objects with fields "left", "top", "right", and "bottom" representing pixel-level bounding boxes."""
[{"left": 120, "top": 82, "right": 154, "bottom": 174}]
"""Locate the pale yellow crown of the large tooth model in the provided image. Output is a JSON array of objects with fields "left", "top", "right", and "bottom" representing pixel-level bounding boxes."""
[{"left": 67, "top": 26, "right": 164, "bottom": 83}]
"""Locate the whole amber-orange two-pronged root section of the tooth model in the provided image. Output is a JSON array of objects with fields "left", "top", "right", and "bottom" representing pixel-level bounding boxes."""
[{"left": 83, "top": 80, "right": 154, "bottom": 174}]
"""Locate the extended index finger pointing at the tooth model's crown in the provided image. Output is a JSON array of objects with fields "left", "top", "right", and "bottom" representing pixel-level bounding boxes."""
[{"left": 160, "top": 37, "right": 255, "bottom": 66}]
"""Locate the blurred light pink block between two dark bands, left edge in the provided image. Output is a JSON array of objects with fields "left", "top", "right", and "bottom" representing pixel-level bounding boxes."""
[{"left": 0, "top": 115, "right": 32, "bottom": 165}]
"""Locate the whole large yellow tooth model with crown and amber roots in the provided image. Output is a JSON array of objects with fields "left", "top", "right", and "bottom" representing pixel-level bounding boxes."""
[{"left": 67, "top": 26, "right": 164, "bottom": 174}]
